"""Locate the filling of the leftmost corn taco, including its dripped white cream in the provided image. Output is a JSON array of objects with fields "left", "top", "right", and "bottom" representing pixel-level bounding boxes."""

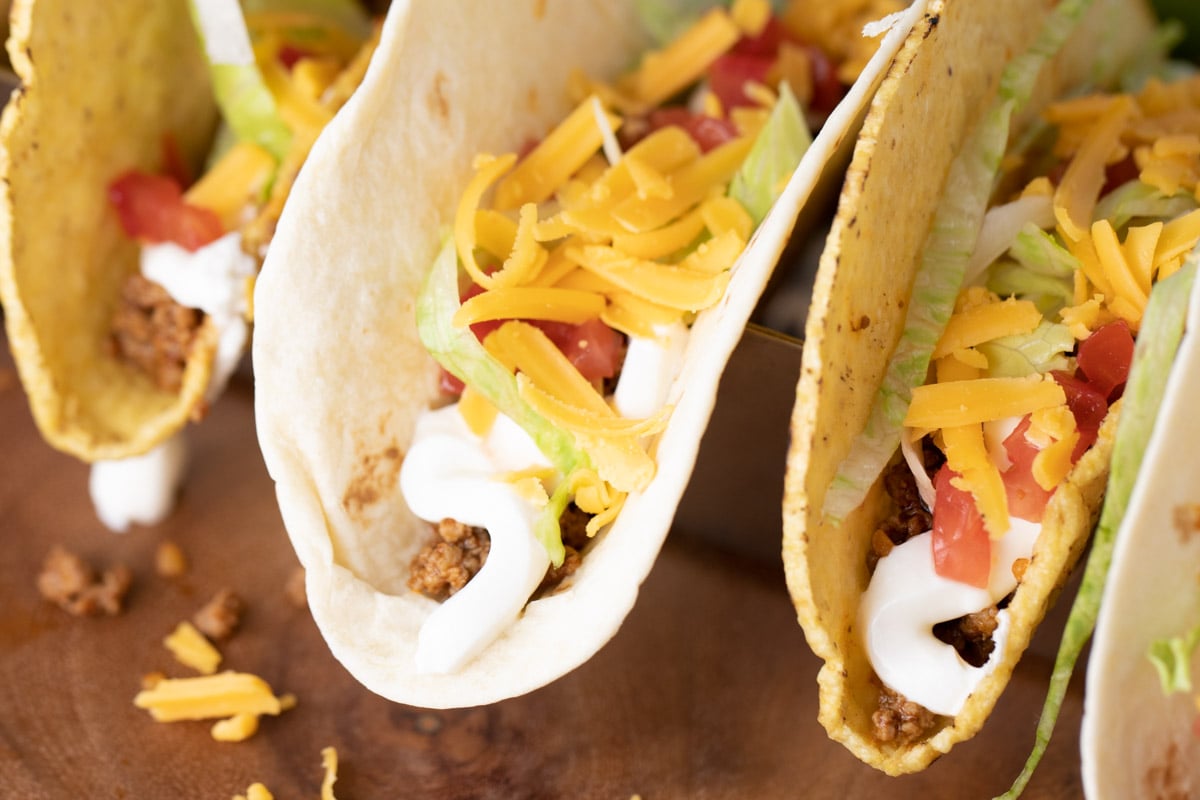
[{"left": 89, "top": 0, "right": 378, "bottom": 530}]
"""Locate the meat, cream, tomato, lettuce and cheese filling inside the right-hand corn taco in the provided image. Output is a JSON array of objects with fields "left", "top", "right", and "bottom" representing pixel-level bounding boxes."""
[{"left": 849, "top": 23, "right": 1200, "bottom": 744}]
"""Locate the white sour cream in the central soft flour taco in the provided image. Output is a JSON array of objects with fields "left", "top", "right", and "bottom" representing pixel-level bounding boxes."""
[{"left": 400, "top": 324, "right": 688, "bottom": 674}]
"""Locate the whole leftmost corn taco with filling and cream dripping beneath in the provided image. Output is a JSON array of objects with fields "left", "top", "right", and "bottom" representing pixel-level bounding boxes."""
[{"left": 0, "top": 0, "right": 372, "bottom": 529}]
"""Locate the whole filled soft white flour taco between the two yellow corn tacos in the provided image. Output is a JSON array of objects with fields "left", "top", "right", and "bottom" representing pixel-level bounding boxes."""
[{"left": 254, "top": 2, "right": 920, "bottom": 706}]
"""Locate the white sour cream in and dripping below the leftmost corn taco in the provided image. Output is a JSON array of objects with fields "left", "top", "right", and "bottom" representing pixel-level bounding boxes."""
[{"left": 88, "top": 233, "right": 258, "bottom": 531}]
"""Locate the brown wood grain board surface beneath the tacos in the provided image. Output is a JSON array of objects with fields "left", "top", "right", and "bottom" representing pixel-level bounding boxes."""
[{"left": 0, "top": 347, "right": 1082, "bottom": 800}]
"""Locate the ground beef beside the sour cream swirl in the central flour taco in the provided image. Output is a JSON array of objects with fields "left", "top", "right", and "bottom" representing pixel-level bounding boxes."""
[{"left": 408, "top": 504, "right": 590, "bottom": 602}]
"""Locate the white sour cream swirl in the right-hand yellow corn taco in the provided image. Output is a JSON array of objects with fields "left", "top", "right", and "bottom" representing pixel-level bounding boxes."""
[{"left": 858, "top": 517, "right": 1042, "bottom": 716}]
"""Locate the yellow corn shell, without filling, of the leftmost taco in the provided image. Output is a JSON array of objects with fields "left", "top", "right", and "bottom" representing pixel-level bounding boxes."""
[{"left": 0, "top": 0, "right": 217, "bottom": 461}]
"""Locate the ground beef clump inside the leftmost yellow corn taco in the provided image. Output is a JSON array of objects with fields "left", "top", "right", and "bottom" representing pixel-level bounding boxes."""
[{"left": 108, "top": 272, "right": 204, "bottom": 392}]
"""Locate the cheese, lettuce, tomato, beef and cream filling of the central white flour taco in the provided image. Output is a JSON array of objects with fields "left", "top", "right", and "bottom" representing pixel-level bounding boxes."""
[{"left": 400, "top": 0, "right": 894, "bottom": 673}]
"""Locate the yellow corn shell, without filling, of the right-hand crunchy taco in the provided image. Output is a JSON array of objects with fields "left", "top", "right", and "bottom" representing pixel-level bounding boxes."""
[{"left": 782, "top": 0, "right": 1152, "bottom": 775}]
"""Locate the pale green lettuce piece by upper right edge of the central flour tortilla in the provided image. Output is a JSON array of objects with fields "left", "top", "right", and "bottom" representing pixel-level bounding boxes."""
[{"left": 730, "top": 83, "right": 812, "bottom": 227}]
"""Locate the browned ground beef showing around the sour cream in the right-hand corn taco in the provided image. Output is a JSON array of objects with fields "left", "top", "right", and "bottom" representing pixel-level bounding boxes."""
[{"left": 866, "top": 449, "right": 1000, "bottom": 745}]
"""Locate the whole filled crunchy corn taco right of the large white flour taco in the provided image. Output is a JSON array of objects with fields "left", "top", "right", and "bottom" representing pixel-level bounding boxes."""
[{"left": 784, "top": 1, "right": 1200, "bottom": 774}]
